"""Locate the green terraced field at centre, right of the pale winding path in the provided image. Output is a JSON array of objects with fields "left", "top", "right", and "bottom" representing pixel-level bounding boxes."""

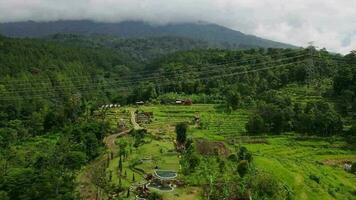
[{"left": 134, "top": 104, "right": 249, "bottom": 139}]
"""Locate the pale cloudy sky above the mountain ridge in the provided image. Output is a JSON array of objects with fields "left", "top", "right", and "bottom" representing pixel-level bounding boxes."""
[{"left": 0, "top": 0, "right": 356, "bottom": 54}]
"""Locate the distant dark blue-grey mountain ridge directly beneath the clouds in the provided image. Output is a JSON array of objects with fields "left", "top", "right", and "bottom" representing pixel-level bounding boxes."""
[{"left": 0, "top": 20, "right": 295, "bottom": 48}]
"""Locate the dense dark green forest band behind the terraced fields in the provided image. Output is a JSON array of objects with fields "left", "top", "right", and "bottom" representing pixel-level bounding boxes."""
[{"left": 0, "top": 35, "right": 354, "bottom": 127}]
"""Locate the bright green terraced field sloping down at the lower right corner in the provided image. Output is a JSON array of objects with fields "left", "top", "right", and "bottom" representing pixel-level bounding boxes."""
[{"left": 243, "top": 136, "right": 356, "bottom": 200}]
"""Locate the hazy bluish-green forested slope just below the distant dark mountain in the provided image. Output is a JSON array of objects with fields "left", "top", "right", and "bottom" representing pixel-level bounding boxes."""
[{"left": 46, "top": 34, "right": 214, "bottom": 63}]
